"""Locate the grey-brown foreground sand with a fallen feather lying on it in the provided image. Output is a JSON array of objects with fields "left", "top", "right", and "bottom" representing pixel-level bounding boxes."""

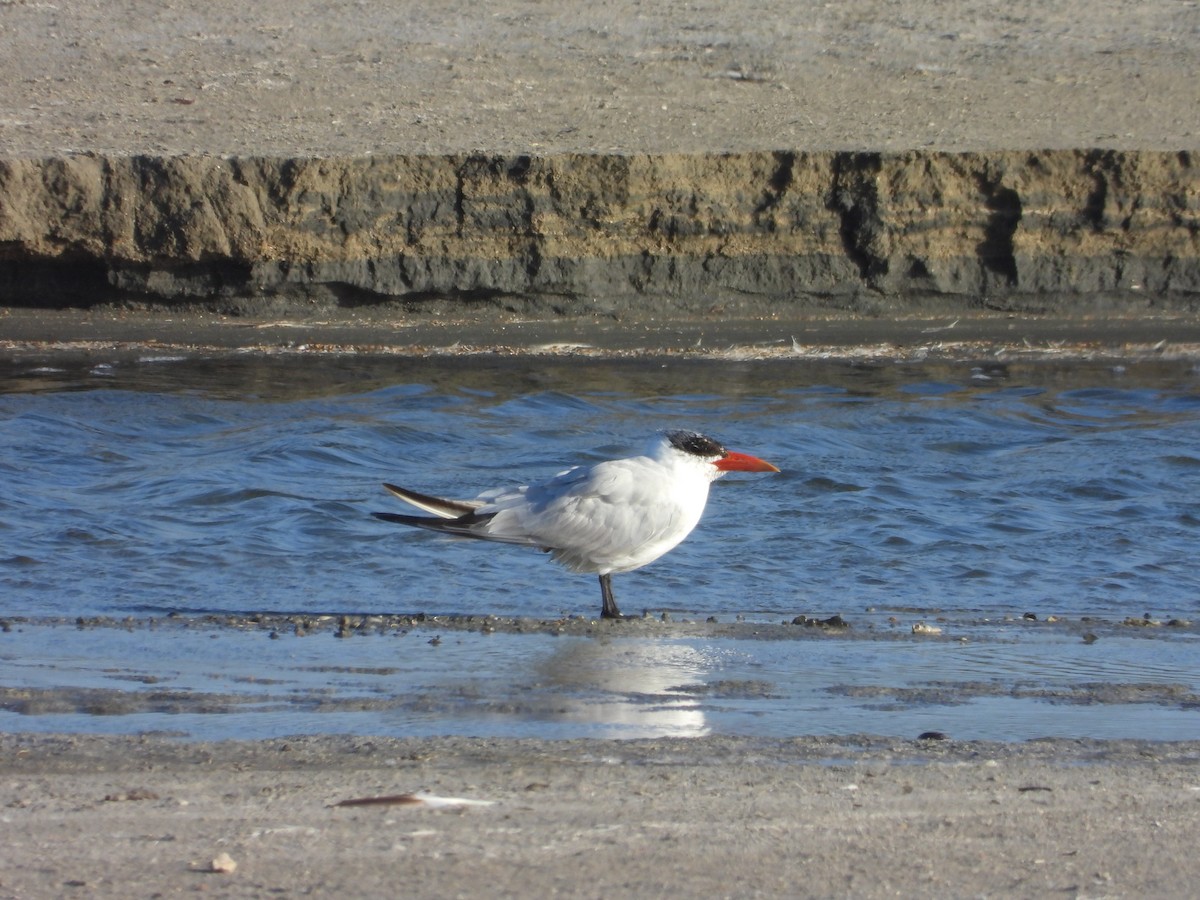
[{"left": 0, "top": 736, "right": 1200, "bottom": 898}]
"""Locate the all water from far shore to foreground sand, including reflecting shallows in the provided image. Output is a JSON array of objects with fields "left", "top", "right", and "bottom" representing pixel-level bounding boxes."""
[{"left": 0, "top": 356, "right": 1200, "bottom": 739}]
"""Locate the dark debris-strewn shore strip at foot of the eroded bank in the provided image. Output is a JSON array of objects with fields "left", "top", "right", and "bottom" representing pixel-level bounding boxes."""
[{"left": 7, "top": 305, "right": 1200, "bottom": 365}]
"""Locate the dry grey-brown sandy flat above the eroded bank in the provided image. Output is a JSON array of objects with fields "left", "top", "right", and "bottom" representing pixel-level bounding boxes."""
[{"left": 0, "top": 0, "right": 1198, "bottom": 157}]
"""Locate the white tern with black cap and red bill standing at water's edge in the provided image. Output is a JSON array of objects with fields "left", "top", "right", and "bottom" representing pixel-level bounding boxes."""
[{"left": 373, "top": 431, "right": 779, "bottom": 618}]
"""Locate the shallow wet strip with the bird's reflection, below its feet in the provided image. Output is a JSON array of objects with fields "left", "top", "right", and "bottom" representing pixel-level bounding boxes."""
[{"left": 0, "top": 610, "right": 1200, "bottom": 744}]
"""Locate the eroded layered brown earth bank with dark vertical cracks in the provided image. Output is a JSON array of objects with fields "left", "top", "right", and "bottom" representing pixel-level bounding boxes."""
[{"left": 0, "top": 150, "right": 1200, "bottom": 314}]
